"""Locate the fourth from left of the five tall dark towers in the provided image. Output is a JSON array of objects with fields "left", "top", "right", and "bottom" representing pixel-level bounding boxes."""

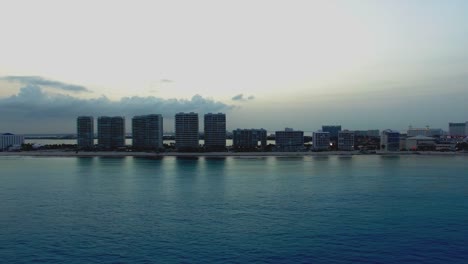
[{"left": 175, "top": 112, "right": 199, "bottom": 150}]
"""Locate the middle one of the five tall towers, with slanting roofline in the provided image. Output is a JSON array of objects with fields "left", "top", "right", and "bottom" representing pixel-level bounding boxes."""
[{"left": 132, "top": 114, "right": 163, "bottom": 150}]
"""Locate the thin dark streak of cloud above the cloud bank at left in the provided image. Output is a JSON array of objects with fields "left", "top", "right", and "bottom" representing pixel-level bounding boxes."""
[{"left": 0, "top": 76, "right": 91, "bottom": 92}]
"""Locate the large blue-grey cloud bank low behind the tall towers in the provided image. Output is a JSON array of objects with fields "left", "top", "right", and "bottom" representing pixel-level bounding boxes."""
[{"left": 0, "top": 85, "right": 232, "bottom": 133}]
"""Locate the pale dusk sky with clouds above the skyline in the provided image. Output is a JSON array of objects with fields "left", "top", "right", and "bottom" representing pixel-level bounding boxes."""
[{"left": 0, "top": 0, "right": 468, "bottom": 134}]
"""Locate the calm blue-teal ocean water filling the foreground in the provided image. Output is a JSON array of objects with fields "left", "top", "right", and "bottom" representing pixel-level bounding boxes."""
[{"left": 0, "top": 156, "right": 468, "bottom": 263}]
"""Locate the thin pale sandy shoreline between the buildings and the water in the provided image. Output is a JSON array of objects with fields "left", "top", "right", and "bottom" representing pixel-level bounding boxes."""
[{"left": 0, "top": 150, "right": 468, "bottom": 158}]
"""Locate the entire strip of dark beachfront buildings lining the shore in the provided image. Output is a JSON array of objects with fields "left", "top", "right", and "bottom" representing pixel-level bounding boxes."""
[{"left": 0, "top": 112, "right": 468, "bottom": 153}]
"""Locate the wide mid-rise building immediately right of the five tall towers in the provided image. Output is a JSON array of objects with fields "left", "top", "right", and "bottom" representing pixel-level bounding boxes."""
[{"left": 232, "top": 128, "right": 267, "bottom": 150}]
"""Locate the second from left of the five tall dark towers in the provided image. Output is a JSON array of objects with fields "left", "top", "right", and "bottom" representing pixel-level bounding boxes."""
[{"left": 98, "top": 116, "right": 125, "bottom": 149}]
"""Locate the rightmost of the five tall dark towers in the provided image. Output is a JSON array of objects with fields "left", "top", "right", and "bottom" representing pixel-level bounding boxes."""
[{"left": 204, "top": 113, "right": 226, "bottom": 150}]
